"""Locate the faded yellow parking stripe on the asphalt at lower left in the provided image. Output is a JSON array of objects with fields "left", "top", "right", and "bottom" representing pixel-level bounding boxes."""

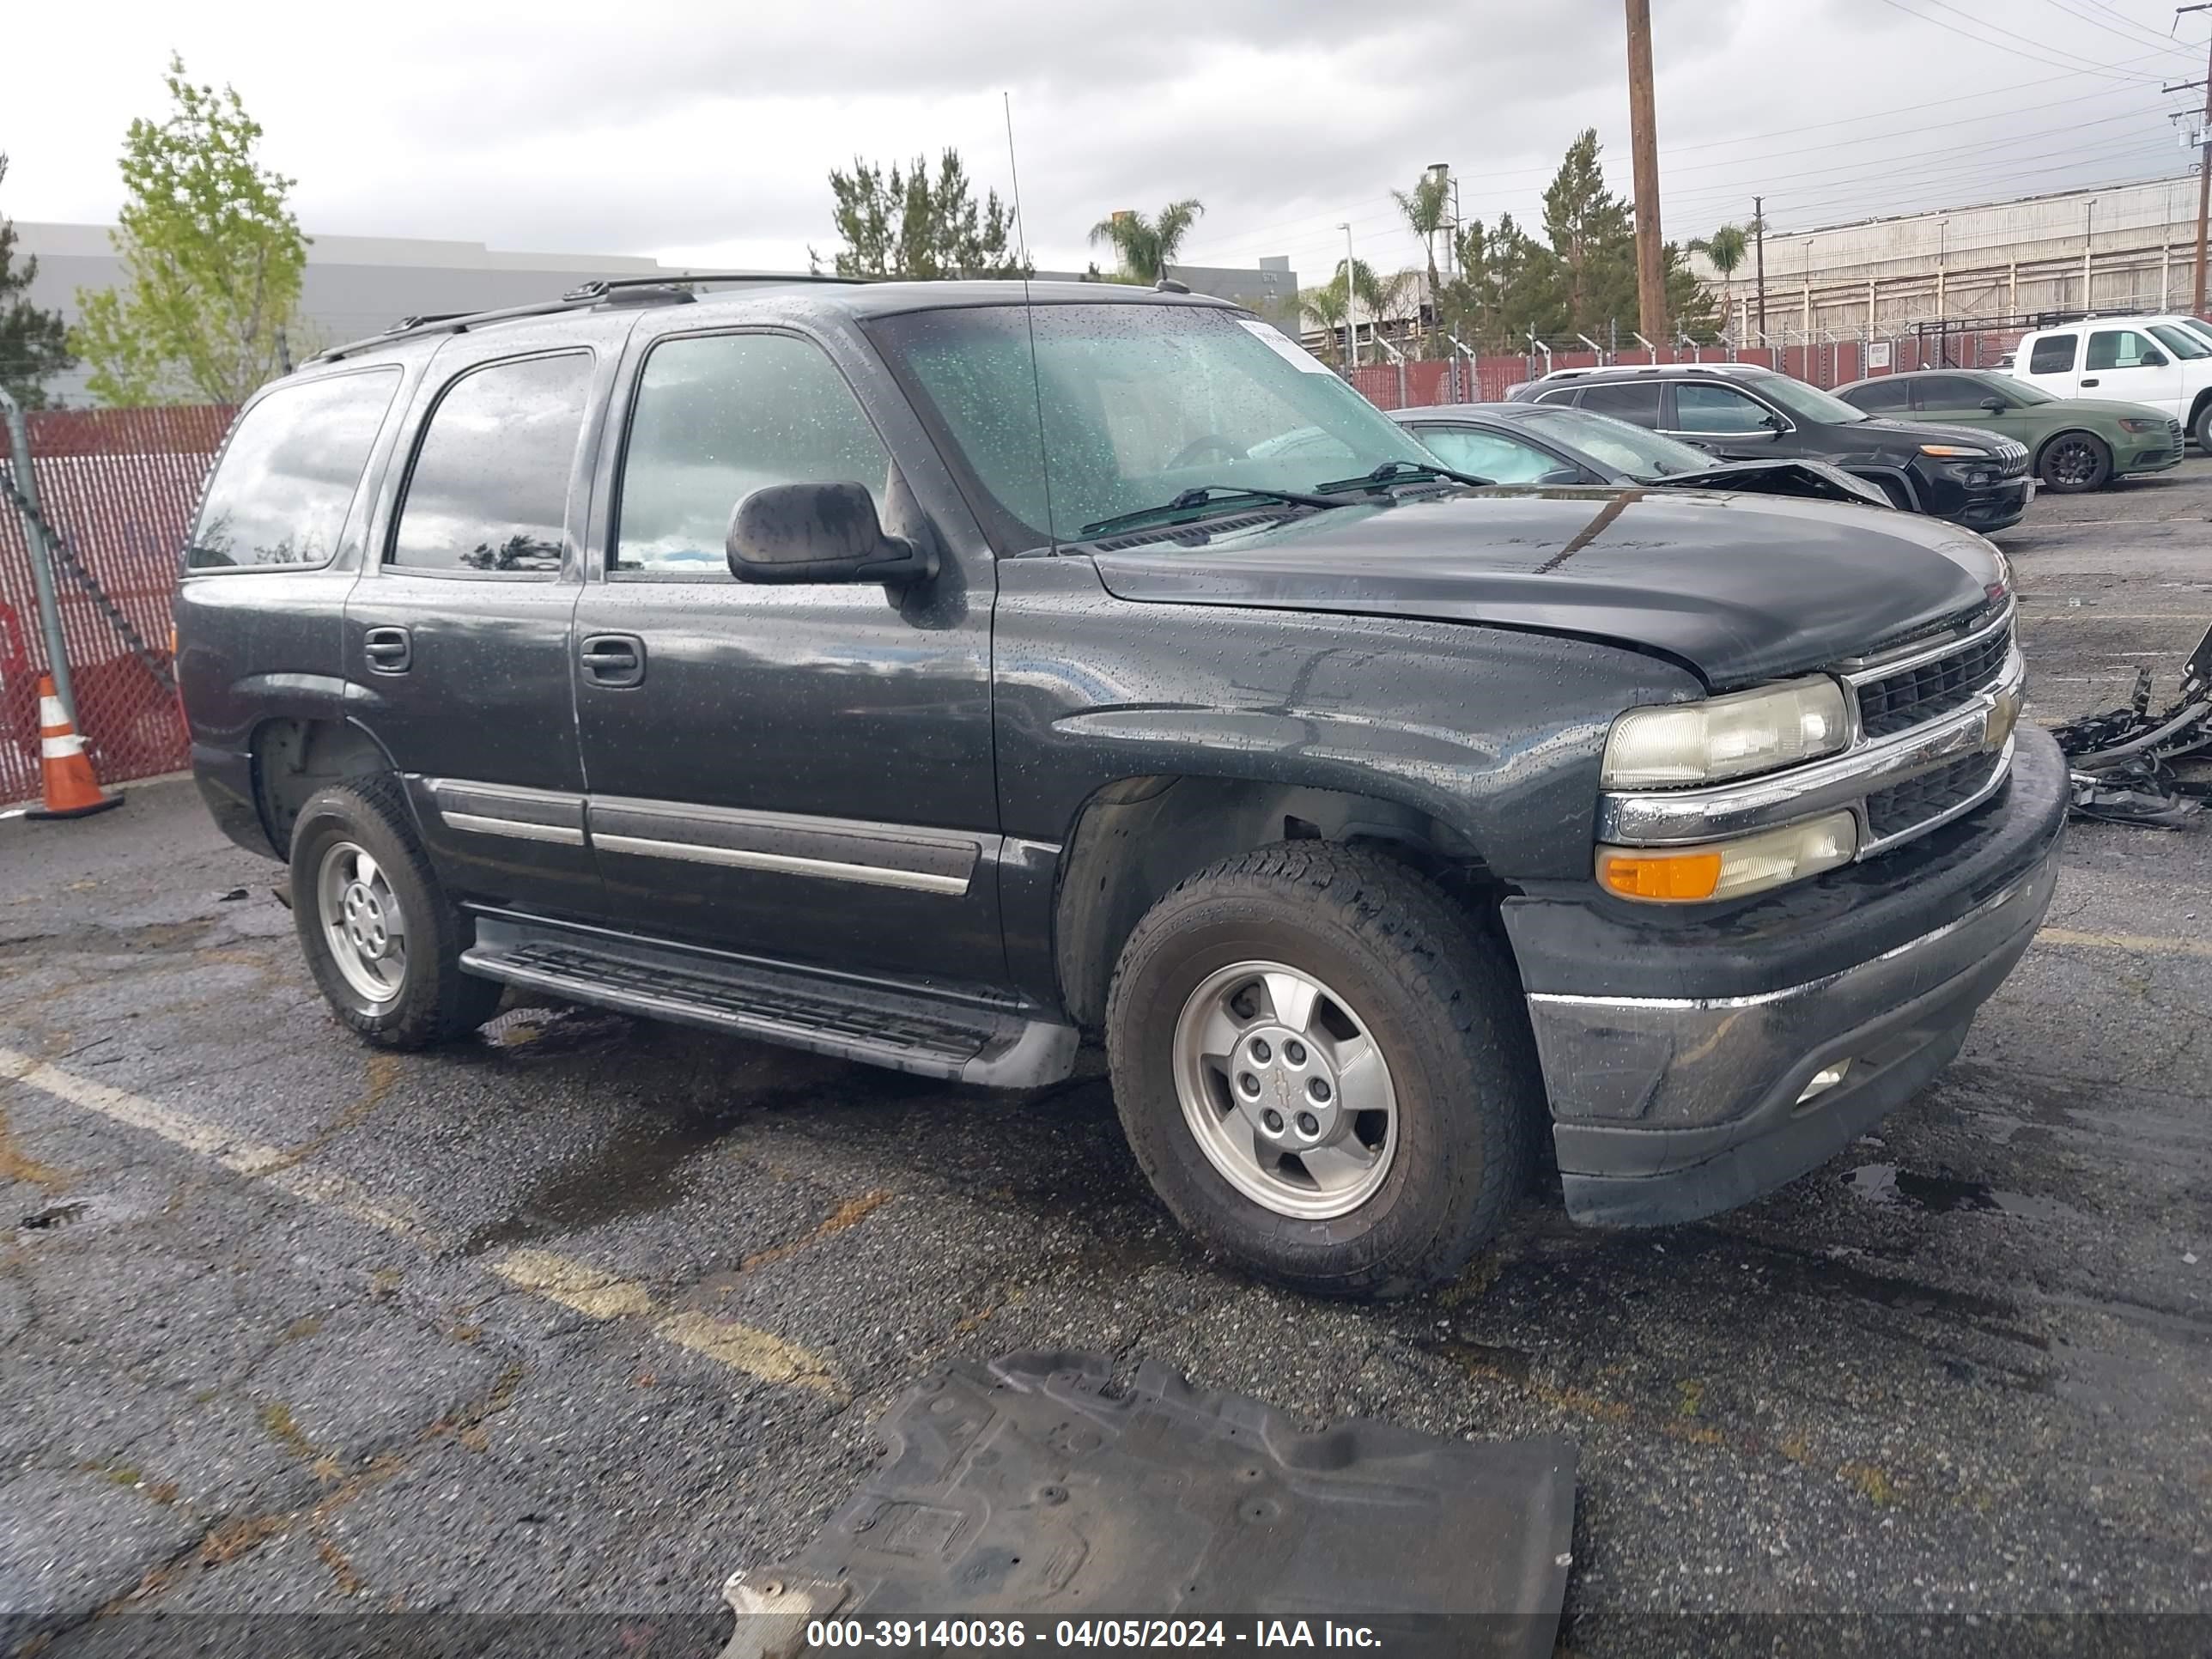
[{"left": 0, "top": 1048, "right": 849, "bottom": 1398}]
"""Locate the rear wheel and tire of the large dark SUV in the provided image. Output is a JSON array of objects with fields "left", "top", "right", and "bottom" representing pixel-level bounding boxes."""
[{"left": 292, "top": 776, "right": 502, "bottom": 1048}]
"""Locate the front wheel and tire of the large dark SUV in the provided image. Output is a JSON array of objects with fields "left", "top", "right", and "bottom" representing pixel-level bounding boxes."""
[{"left": 1106, "top": 842, "right": 1541, "bottom": 1297}]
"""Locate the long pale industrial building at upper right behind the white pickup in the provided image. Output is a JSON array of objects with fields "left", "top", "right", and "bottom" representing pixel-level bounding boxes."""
[{"left": 1690, "top": 173, "right": 2197, "bottom": 343}]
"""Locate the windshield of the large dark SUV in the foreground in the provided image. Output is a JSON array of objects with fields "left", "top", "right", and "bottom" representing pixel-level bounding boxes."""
[{"left": 874, "top": 305, "right": 1436, "bottom": 542}]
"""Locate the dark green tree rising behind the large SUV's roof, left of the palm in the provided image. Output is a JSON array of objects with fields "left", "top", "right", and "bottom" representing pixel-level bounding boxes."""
[{"left": 807, "top": 149, "right": 1029, "bottom": 281}]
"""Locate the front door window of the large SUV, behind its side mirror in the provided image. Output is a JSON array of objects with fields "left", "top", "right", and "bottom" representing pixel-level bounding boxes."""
[{"left": 608, "top": 334, "right": 891, "bottom": 581}]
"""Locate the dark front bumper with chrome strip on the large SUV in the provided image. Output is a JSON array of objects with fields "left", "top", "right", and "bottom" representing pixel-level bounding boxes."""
[{"left": 1504, "top": 728, "right": 2066, "bottom": 1225}]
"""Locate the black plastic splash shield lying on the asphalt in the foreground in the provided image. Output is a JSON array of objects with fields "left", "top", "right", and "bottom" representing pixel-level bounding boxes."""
[{"left": 726, "top": 1352, "right": 1575, "bottom": 1659}]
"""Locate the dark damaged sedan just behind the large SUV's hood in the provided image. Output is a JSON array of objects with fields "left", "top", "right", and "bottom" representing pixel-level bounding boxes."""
[{"left": 1391, "top": 403, "right": 1889, "bottom": 507}]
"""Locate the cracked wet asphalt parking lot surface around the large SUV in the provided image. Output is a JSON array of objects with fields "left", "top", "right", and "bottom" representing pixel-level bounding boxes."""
[{"left": 0, "top": 471, "right": 2212, "bottom": 1652}]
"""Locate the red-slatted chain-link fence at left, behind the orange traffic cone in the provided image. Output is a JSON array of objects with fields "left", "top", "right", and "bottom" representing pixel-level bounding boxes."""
[{"left": 0, "top": 407, "right": 234, "bottom": 801}]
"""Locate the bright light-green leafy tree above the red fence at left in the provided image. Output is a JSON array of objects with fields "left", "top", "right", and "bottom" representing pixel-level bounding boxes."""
[{"left": 69, "top": 53, "right": 307, "bottom": 404}]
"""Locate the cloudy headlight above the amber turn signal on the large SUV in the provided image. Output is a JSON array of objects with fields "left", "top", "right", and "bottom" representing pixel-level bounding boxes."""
[{"left": 1601, "top": 675, "right": 1850, "bottom": 790}]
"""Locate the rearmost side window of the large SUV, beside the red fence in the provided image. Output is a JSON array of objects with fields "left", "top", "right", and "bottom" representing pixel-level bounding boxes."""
[{"left": 184, "top": 368, "right": 400, "bottom": 571}]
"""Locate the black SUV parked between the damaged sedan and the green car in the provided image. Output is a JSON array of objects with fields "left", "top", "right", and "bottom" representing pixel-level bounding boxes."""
[{"left": 1513, "top": 362, "right": 2035, "bottom": 531}]
